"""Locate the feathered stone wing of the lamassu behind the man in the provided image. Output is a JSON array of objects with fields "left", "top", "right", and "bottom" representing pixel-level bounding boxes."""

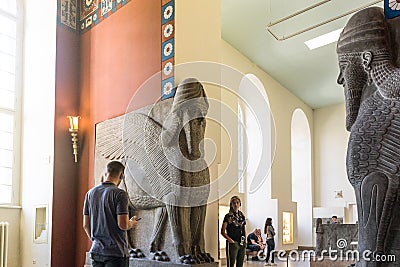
[{"left": 96, "top": 112, "right": 180, "bottom": 203}]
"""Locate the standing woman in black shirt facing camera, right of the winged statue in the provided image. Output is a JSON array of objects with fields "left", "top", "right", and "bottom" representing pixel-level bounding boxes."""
[{"left": 221, "top": 196, "right": 246, "bottom": 267}]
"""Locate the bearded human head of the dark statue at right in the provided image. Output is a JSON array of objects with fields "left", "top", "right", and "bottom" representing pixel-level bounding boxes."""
[{"left": 336, "top": 7, "right": 390, "bottom": 130}]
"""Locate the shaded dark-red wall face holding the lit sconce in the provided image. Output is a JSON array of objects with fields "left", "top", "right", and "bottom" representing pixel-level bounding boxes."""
[{"left": 51, "top": 26, "right": 82, "bottom": 267}]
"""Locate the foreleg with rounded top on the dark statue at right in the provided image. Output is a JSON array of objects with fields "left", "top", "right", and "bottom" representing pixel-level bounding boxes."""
[{"left": 354, "top": 173, "right": 388, "bottom": 267}]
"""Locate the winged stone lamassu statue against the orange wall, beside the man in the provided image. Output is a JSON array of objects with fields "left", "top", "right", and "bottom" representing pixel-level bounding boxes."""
[{"left": 97, "top": 78, "right": 213, "bottom": 264}]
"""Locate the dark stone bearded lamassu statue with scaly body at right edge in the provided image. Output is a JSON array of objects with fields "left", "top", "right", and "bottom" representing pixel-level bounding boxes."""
[{"left": 337, "top": 7, "right": 400, "bottom": 266}]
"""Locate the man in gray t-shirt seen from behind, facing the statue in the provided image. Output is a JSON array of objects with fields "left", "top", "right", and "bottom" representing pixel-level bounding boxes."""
[{"left": 83, "top": 161, "right": 137, "bottom": 267}]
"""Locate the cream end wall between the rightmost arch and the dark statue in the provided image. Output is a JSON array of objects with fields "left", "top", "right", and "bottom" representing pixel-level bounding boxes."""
[{"left": 314, "top": 103, "right": 355, "bottom": 222}]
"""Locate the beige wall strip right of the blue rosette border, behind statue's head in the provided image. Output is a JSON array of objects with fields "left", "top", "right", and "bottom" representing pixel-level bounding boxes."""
[{"left": 175, "top": 0, "right": 221, "bottom": 259}]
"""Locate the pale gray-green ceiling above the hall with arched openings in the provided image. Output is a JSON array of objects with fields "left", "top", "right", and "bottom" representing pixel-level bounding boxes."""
[{"left": 221, "top": 0, "right": 383, "bottom": 109}]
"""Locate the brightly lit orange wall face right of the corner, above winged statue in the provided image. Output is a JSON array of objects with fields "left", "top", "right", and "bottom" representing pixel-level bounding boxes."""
[{"left": 76, "top": 0, "right": 161, "bottom": 267}]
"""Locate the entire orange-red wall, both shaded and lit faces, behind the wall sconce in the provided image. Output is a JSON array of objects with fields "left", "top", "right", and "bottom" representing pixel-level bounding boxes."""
[{"left": 51, "top": 0, "right": 161, "bottom": 267}]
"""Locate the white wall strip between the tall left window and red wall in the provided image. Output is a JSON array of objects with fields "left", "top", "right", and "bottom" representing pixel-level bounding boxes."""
[{"left": 21, "top": 0, "right": 57, "bottom": 267}]
